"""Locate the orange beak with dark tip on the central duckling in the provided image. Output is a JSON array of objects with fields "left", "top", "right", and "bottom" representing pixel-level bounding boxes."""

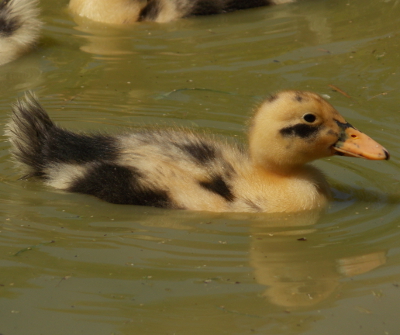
[{"left": 333, "top": 121, "right": 390, "bottom": 160}]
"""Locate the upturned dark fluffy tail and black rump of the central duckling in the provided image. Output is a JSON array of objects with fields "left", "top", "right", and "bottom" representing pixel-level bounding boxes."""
[{"left": 5, "top": 92, "right": 118, "bottom": 182}]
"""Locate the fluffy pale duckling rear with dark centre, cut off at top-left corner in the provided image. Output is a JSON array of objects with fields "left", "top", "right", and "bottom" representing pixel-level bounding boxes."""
[{"left": 0, "top": 0, "right": 42, "bottom": 65}]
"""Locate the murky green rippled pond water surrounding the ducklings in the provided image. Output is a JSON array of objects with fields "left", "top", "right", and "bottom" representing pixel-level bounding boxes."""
[{"left": 0, "top": 0, "right": 400, "bottom": 335}]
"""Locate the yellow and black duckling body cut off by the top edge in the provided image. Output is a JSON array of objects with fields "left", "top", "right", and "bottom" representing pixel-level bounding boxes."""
[{"left": 69, "top": 0, "right": 294, "bottom": 24}]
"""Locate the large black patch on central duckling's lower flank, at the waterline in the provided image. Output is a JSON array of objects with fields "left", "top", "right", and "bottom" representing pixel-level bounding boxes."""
[{"left": 68, "top": 162, "right": 177, "bottom": 208}]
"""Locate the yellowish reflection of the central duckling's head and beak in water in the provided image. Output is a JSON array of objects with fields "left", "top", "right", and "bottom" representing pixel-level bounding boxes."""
[{"left": 250, "top": 212, "right": 386, "bottom": 308}]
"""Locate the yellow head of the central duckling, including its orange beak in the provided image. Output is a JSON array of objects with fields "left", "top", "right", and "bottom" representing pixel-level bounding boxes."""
[{"left": 249, "top": 91, "right": 389, "bottom": 173}]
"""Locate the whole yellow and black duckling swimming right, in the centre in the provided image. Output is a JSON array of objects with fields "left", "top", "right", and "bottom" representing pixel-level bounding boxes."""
[{"left": 6, "top": 91, "right": 389, "bottom": 212}]
